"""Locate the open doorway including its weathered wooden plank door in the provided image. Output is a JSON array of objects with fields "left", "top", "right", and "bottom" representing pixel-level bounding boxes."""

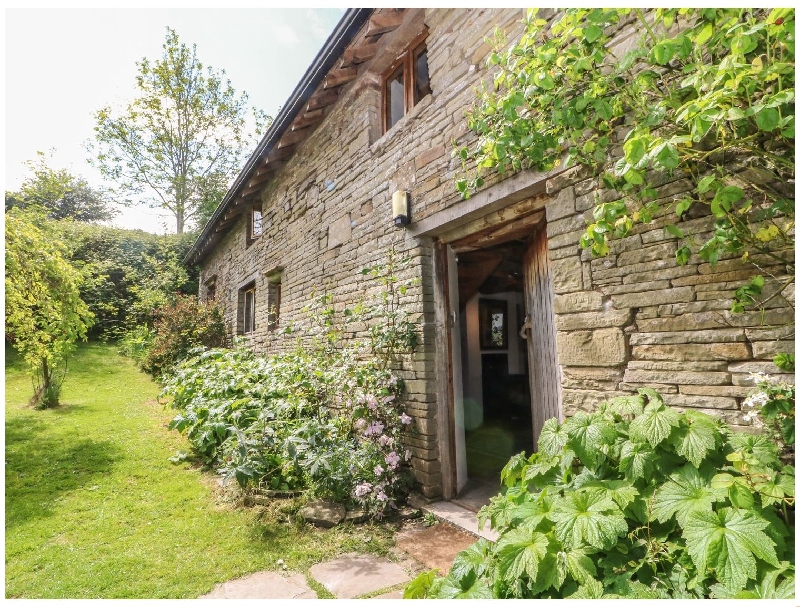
[{"left": 440, "top": 207, "right": 561, "bottom": 511}]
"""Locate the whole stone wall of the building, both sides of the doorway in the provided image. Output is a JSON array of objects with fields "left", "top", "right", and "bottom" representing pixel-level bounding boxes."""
[{"left": 201, "top": 9, "right": 794, "bottom": 497}]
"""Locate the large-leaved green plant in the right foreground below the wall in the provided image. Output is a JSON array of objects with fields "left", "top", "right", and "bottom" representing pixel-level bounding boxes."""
[{"left": 405, "top": 389, "right": 794, "bottom": 598}]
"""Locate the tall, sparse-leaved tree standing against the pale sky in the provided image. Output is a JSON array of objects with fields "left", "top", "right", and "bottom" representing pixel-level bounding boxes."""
[{"left": 89, "top": 28, "right": 269, "bottom": 234}]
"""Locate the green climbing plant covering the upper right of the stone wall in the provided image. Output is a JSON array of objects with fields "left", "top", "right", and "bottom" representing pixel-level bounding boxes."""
[{"left": 456, "top": 8, "right": 795, "bottom": 311}]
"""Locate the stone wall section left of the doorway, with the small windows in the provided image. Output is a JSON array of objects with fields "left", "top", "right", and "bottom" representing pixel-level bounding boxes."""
[{"left": 201, "top": 9, "right": 523, "bottom": 497}]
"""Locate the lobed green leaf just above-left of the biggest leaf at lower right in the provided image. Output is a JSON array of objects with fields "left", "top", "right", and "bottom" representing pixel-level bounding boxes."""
[{"left": 652, "top": 464, "right": 725, "bottom": 527}]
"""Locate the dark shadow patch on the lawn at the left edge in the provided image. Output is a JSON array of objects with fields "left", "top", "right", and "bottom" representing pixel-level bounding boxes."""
[{"left": 5, "top": 417, "right": 122, "bottom": 530}]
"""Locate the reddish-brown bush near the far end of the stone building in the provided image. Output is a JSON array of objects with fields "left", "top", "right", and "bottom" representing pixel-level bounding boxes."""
[{"left": 141, "top": 295, "right": 226, "bottom": 376}]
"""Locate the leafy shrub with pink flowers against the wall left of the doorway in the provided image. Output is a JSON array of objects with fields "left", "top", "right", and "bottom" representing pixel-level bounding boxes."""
[{"left": 158, "top": 253, "right": 416, "bottom": 516}]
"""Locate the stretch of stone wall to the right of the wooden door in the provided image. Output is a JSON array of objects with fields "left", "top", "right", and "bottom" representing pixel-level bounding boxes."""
[{"left": 547, "top": 168, "right": 794, "bottom": 425}]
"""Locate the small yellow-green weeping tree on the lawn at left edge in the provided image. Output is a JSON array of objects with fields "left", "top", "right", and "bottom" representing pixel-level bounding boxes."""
[{"left": 5, "top": 209, "right": 92, "bottom": 408}]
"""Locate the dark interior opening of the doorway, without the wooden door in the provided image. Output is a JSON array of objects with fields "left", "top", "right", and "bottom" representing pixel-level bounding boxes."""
[{"left": 457, "top": 240, "right": 533, "bottom": 510}]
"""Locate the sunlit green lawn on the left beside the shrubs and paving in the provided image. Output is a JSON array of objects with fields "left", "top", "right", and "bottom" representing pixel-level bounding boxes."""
[{"left": 5, "top": 344, "right": 393, "bottom": 599}]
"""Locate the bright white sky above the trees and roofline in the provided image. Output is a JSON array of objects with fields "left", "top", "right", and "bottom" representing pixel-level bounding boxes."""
[{"left": 4, "top": 8, "right": 343, "bottom": 234}]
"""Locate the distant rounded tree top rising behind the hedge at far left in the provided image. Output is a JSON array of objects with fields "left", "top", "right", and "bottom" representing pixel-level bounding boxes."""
[{"left": 6, "top": 152, "right": 117, "bottom": 222}]
